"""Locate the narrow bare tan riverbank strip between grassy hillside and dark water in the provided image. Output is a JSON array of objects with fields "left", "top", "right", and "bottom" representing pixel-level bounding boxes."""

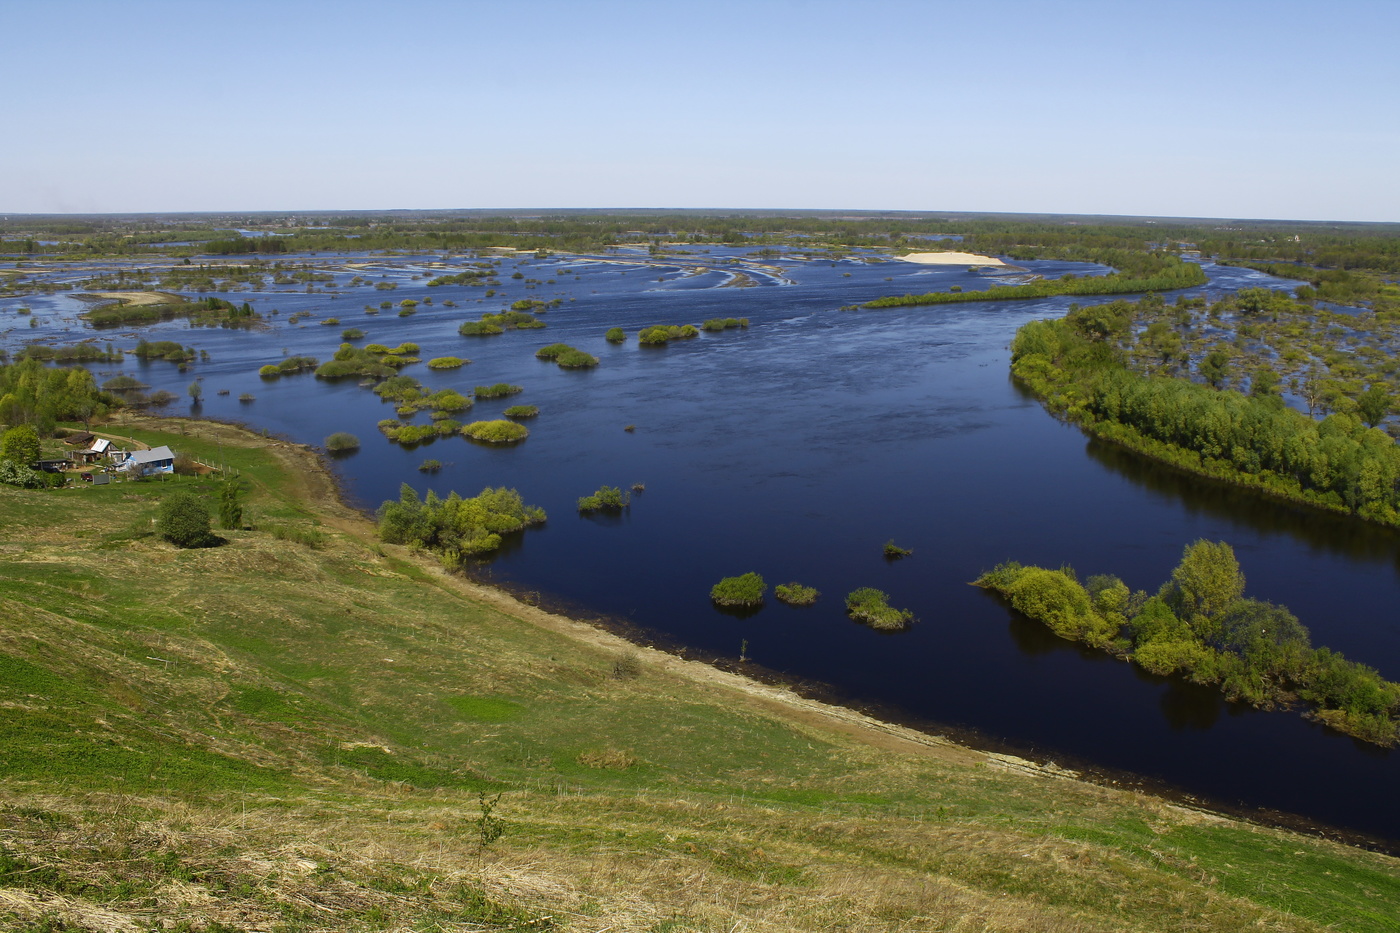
[{"left": 120, "top": 415, "right": 1400, "bottom": 857}]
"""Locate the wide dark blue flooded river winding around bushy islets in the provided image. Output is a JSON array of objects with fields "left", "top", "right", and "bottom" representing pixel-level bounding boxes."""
[{"left": 0, "top": 248, "right": 1400, "bottom": 845}]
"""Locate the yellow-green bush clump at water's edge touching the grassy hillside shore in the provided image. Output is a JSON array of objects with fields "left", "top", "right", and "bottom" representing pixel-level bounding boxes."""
[{"left": 377, "top": 483, "right": 545, "bottom": 567}]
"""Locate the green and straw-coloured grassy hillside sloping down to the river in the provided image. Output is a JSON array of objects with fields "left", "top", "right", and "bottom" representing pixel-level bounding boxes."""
[{"left": 0, "top": 422, "right": 1400, "bottom": 933}]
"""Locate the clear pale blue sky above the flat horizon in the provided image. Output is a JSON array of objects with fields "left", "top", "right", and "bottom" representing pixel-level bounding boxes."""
[{"left": 0, "top": 0, "right": 1400, "bottom": 221}]
